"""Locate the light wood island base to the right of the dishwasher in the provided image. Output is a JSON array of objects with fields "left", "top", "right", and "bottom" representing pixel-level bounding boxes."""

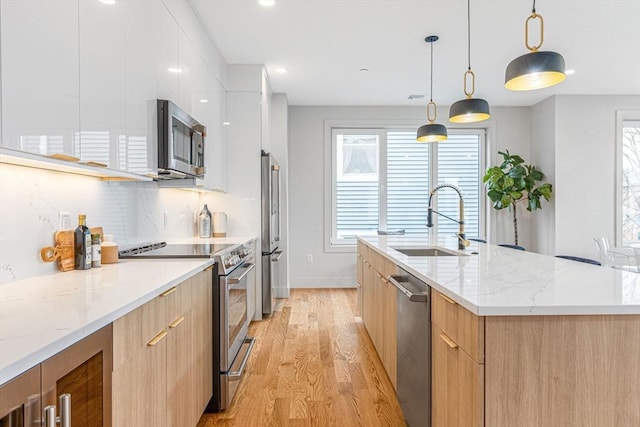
[{"left": 431, "top": 291, "right": 640, "bottom": 427}]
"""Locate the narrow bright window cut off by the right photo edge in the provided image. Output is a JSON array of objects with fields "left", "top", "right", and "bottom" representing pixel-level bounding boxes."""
[{"left": 618, "top": 112, "right": 640, "bottom": 246}]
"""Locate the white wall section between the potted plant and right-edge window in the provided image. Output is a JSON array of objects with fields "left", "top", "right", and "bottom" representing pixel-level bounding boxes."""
[{"left": 555, "top": 95, "right": 640, "bottom": 258}]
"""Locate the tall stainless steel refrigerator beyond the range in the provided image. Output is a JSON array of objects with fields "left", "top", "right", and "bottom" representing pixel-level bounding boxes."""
[{"left": 262, "top": 150, "right": 282, "bottom": 315}]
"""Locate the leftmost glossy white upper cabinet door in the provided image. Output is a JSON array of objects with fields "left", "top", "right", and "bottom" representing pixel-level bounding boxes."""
[{"left": 0, "top": 0, "right": 80, "bottom": 155}]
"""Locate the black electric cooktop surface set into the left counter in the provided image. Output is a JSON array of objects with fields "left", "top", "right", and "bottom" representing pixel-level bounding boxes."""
[{"left": 118, "top": 242, "right": 235, "bottom": 258}]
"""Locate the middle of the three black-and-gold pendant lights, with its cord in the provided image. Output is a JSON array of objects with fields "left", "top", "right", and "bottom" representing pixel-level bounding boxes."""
[{"left": 449, "top": 0, "right": 491, "bottom": 123}]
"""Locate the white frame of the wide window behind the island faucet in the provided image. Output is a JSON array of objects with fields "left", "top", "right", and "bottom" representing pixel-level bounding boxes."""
[{"left": 323, "top": 120, "right": 492, "bottom": 253}]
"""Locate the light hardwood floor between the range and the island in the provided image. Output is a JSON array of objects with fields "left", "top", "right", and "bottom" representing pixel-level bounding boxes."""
[{"left": 198, "top": 289, "right": 405, "bottom": 427}]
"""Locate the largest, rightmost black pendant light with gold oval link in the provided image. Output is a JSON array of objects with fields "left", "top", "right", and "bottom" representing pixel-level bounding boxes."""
[{"left": 504, "top": 0, "right": 566, "bottom": 90}]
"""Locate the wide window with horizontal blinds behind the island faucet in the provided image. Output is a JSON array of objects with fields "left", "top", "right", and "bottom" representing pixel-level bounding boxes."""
[{"left": 327, "top": 127, "right": 485, "bottom": 250}]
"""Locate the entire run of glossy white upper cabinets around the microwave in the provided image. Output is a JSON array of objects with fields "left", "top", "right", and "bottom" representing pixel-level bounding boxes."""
[{"left": 0, "top": 0, "right": 227, "bottom": 191}]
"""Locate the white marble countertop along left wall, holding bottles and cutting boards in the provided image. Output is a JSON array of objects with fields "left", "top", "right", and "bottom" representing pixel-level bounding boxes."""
[{"left": 0, "top": 260, "right": 215, "bottom": 385}]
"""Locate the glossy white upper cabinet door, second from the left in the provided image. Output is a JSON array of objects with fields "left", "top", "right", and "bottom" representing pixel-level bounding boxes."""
[{"left": 75, "top": 0, "right": 126, "bottom": 170}]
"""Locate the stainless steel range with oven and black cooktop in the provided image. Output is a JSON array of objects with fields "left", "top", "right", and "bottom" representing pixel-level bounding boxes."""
[{"left": 118, "top": 240, "right": 256, "bottom": 412}]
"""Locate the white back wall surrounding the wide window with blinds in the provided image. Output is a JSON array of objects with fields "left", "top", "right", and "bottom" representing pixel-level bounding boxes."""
[{"left": 289, "top": 107, "right": 529, "bottom": 288}]
